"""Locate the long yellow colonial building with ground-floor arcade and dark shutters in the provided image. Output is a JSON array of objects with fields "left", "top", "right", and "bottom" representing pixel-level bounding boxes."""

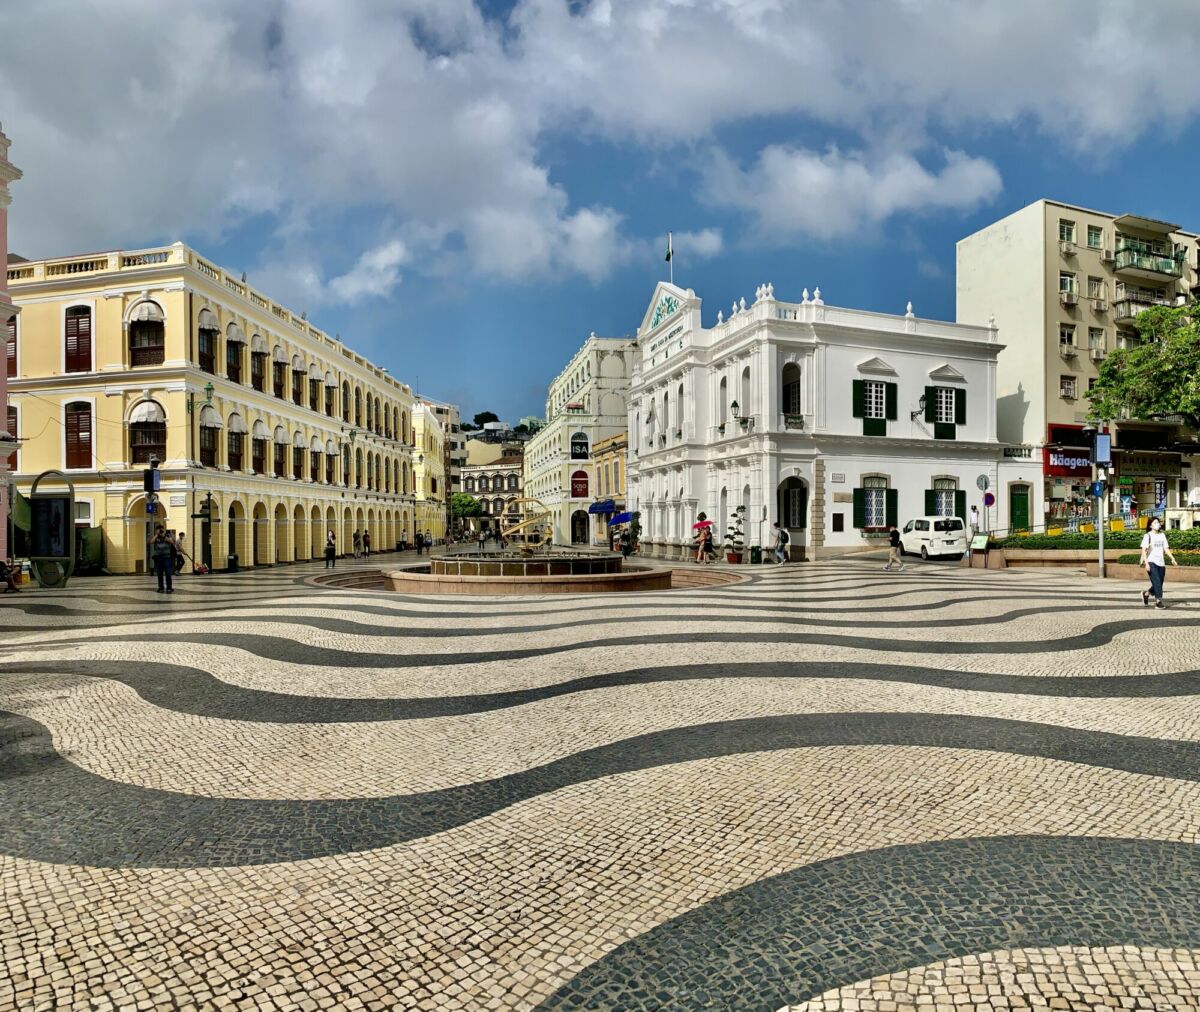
[{"left": 7, "top": 242, "right": 444, "bottom": 573}]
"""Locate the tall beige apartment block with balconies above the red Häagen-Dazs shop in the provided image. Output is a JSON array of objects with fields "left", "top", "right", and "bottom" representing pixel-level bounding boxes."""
[{"left": 956, "top": 199, "right": 1198, "bottom": 521}]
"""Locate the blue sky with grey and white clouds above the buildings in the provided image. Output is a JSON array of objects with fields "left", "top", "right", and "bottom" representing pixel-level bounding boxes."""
[{"left": 7, "top": 0, "right": 1200, "bottom": 421}]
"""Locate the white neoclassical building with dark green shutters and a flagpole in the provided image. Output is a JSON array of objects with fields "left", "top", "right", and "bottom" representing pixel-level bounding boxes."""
[{"left": 628, "top": 283, "right": 1042, "bottom": 558}]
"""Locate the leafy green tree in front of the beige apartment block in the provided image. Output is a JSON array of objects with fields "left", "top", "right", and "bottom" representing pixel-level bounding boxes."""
[{"left": 1087, "top": 306, "right": 1200, "bottom": 429}]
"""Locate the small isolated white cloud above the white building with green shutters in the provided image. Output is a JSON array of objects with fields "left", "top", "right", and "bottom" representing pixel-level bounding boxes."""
[{"left": 706, "top": 146, "right": 1001, "bottom": 242}]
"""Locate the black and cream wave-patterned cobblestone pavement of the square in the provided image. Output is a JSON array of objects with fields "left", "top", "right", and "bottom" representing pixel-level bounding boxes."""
[{"left": 0, "top": 561, "right": 1200, "bottom": 1012}]
